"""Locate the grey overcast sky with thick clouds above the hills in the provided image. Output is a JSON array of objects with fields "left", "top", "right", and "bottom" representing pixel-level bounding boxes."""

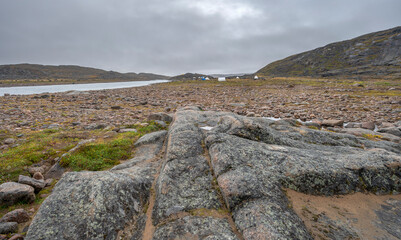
[{"left": 0, "top": 0, "right": 401, "bottom": 75}]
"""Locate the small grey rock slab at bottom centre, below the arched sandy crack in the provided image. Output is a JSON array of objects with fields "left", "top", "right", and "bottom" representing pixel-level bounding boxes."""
[{"left": 153, "top": 216, "right": 239, "bottom": 240}]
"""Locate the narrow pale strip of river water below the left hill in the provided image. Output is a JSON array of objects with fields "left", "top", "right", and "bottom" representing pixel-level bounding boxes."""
[{"left": 0, "top": 80, "right": 169, "bottom": 96}]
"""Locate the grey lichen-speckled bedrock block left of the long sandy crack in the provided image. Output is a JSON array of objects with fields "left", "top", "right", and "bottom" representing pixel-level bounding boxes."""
[{"left": 27, "top": 163, "right": 156, "bottom": 239}]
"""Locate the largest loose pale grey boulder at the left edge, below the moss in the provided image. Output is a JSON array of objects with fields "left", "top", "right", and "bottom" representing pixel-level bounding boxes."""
[{"left": 0, "top": 182, "right": 35, "bottom": 206}]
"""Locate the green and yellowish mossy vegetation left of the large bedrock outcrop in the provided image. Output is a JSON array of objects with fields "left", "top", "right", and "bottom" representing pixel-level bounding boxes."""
[{"left": 0, "top": 122, "right": 162, "bottom": 184}]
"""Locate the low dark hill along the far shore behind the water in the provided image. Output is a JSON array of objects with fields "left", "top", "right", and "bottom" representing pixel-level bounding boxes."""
[{"left": 0, "top": 64, "right": 169, "bottom": 81}]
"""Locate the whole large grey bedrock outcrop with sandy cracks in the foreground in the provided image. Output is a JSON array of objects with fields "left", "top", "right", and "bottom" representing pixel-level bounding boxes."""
[{"left": 4, "top": 107, "right": 401, "bottom": 240}]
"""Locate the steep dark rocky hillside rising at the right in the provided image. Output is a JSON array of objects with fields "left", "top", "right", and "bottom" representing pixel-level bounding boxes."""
[{"left": 256, "top": 27, "right": 401, "bottom": 78}]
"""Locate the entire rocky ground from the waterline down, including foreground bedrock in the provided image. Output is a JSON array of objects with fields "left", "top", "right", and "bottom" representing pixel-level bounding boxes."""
[{"left": 0, "top": 78, "right": 401, "bottom": 239}]
